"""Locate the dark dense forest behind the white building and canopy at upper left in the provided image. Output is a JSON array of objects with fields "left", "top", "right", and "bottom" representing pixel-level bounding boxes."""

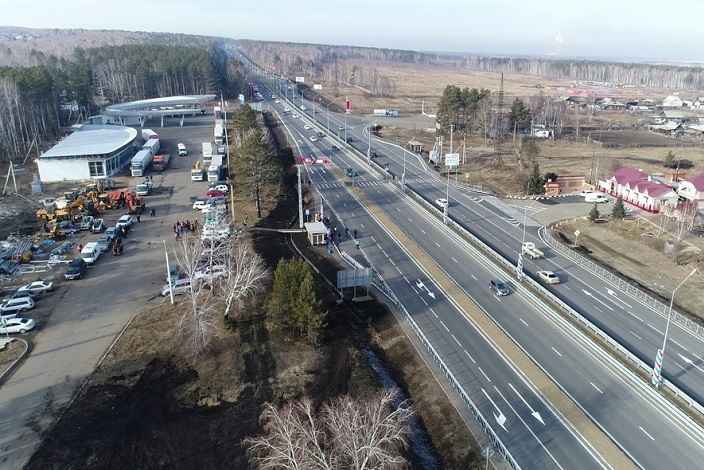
[{"left": 0, "top": 43, "right": 244, "bottom": 163}]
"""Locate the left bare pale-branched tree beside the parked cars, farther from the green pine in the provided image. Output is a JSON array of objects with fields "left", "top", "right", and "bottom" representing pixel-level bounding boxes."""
[{"left": 174, "top": 232, "right": 219, "bottom": 357}]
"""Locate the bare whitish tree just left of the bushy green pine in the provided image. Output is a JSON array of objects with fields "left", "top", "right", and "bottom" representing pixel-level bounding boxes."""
[{"left": 221, "top": 239, "right": 269, "bottom": 318}]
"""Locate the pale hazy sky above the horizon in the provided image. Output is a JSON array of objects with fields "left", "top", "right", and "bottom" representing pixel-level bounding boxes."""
[{"left": 0, "top": 0, "right": 704, "bottom": 62}]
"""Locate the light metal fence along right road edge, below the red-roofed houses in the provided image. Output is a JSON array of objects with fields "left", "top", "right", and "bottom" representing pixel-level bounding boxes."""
[{"left": 540, "top": 227, "right": 704, "bottom": 340}]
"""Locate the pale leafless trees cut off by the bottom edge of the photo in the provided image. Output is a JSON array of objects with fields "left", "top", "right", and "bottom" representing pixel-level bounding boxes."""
[{"left": 244, "top": 389, "right": 414, "bottom": 470}]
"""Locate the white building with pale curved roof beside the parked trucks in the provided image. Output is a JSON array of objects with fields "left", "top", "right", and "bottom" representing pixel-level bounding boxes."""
[{"left": 37, "top": 124, "right": 137, "bottom": 183}]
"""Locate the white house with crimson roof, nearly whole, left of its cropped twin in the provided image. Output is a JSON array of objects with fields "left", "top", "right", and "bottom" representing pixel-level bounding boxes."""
[{"left": 597, "top": 168, "right": 678, "bottom": 213}]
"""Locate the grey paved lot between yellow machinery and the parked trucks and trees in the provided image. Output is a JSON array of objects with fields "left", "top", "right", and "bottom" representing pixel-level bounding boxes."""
[{"left": 0, "top": 115, "right": 214, "bottom": 469}]
